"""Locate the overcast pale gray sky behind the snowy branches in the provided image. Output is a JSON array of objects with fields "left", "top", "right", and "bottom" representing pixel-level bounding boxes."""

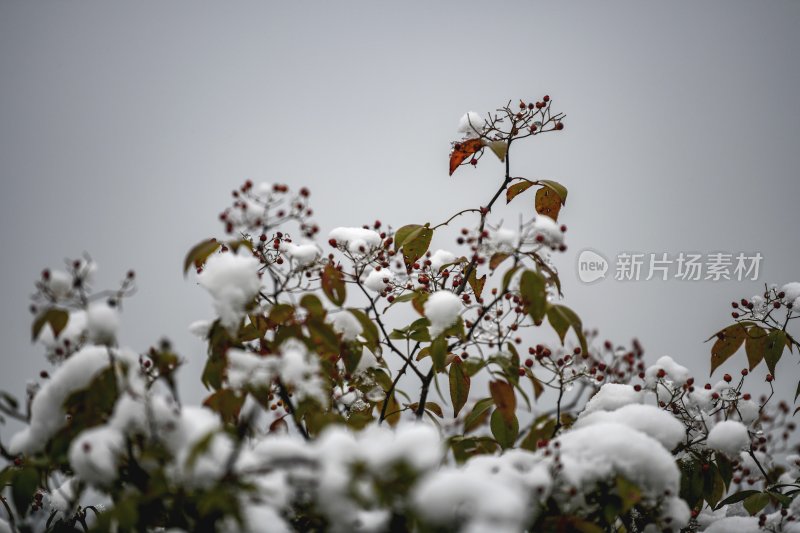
[{"left": 0, "top": 0, "right": 800, "bottom": 412}]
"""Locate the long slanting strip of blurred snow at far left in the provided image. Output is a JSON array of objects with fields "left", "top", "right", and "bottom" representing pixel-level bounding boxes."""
[{"left": 9, "top": 346, "right": 117, "bottom": 454}]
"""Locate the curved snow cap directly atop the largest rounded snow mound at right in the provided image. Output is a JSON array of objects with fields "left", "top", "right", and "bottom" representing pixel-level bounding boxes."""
[{"left": 573, "top": 404, "right": 686, "bottom": 450}]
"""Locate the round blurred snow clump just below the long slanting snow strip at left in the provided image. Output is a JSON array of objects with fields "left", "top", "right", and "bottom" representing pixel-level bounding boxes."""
[{"left": 69, "top": 426, "right": 125, "bottom": 486}]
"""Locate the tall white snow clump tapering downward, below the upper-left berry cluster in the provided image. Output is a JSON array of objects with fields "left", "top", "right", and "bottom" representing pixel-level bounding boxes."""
[{"left": 197, "top": 252, "right": 261, "bottom": 332}]
